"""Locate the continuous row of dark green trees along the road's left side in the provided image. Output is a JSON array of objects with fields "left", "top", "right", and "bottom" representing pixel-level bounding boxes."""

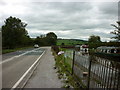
[{"left": 1, "top": 16, "right": 57, "bottom": 49}]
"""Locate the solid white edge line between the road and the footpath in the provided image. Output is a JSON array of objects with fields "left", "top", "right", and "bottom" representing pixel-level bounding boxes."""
[{"left": 11, "top": 51, "right": 45, "bottom": 90}]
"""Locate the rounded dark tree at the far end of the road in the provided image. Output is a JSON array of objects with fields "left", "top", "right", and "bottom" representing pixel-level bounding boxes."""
[{"left": 46, "top": 32, "right": 57, "bottom": 45}]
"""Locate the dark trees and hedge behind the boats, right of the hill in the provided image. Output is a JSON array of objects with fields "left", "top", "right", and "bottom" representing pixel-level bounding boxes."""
[{"left": 88, "top": 21, "right": 120, "bottom": 48}]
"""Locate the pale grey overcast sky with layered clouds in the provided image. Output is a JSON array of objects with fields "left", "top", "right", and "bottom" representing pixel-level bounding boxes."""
[{"left": 0, "top": 0, "right": 118, "bottom": 41}]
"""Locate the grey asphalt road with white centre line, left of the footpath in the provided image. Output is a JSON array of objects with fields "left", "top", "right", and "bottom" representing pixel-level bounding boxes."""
[{"left": 2, "top": 48, "right": 45, "bottom": 88}]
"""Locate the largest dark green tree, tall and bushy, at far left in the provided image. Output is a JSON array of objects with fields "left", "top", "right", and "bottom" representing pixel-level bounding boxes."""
[{"left": 2, "top": 16, "right": 29, "bottom": 48}]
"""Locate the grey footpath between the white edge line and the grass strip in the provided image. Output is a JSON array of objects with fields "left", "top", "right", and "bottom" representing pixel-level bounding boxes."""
[{"left": 24, "top": 47, "right": 63, "bottom": 88}]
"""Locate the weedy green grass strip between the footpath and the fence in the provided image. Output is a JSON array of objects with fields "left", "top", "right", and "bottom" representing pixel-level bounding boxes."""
[{"left": 53, "top": 47, "right": 79, "bottom": 88}]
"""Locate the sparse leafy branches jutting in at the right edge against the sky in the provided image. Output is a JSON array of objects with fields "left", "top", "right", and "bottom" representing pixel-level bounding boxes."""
[{"left": 110, "top": 21, "right": 120, "bottom": 42}]
